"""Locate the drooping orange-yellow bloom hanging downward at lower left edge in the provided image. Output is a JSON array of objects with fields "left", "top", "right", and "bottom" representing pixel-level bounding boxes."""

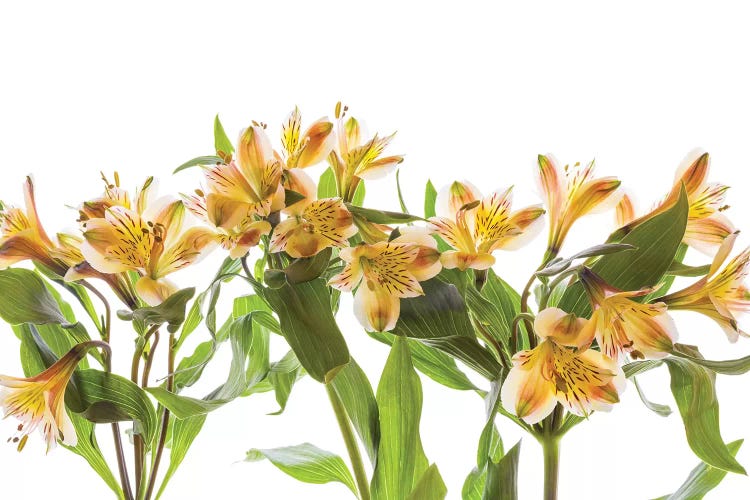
[{"left": 0, "top": 342, "right": 99, "bottom": 452}]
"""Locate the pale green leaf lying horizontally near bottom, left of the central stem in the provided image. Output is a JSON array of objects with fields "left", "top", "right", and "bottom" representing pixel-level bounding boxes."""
[{"left": 245, "top": 443, "right": 357, "bottom": 495}]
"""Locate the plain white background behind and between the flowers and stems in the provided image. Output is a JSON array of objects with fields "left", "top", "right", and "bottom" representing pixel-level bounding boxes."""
[{"left": 0, "top": 1, "right": 750, "bottom": 499}]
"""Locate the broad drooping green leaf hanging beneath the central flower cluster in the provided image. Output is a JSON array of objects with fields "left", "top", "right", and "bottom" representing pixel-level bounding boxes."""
[{"left": 263, "top": 278, "right": 349, "bottom": 382}]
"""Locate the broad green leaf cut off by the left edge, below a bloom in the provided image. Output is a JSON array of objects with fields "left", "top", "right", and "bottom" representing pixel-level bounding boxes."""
[{"left": 0, "top": 268, "right": 68, "bottom": 325}]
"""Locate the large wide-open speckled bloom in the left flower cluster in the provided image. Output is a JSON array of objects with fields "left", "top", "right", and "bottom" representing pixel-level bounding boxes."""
[{"left": 81, "top": 201, "right": 216, "bottom": 305}]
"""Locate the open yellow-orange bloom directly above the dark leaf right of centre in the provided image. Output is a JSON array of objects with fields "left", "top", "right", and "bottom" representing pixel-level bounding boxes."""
[{"left": 430, "top": 181, "right": 544, "bottom": 271}]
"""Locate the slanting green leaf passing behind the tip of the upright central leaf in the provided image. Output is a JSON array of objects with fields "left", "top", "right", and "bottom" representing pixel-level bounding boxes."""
[{"left": 368, "top": 332, "right": 479, "bottom": 391}]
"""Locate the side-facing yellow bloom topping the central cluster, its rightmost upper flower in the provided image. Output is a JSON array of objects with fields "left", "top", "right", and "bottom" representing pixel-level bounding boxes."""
[{"left": 328, "top": 103, "right": 404, "bottom": 201}]
